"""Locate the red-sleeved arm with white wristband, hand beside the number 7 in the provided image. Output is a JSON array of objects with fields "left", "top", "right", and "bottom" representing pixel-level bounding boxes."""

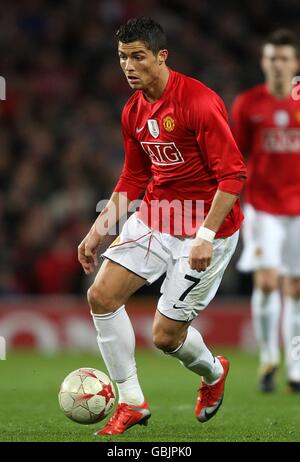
[{"left": 189, "top": 95, "right": 246, "bottom": 271}]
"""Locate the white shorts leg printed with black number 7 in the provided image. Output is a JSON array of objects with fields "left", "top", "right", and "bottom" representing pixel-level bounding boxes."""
[{"left": 157, "top": 232, "right": 238, "bottom": 321}]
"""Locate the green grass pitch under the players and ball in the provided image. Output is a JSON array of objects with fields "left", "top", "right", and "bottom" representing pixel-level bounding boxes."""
[{"left": 0, "top": 349, "right": 300, "bottom": 442}]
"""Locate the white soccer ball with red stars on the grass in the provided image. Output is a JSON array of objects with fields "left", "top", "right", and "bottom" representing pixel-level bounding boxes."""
[{"left": 58, "top": 367, "right": 116, "bottom": 424}]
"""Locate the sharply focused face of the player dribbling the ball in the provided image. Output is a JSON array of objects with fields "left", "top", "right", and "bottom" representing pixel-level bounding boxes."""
[{"left": 118, "top": 41, "right": 167, "bottom": 90}]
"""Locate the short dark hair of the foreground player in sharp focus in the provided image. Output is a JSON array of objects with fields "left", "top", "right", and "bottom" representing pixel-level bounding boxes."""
[{"left": 116, "top": 16, "right": 167, "bottom": 55}]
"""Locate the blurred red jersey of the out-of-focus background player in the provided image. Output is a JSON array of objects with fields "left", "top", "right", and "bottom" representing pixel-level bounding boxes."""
[{"left": 232, "top": 84, "right": 300, "bottom": 215}]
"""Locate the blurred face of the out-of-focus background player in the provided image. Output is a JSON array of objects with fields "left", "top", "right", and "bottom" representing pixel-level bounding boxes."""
[{"left": 261, "top": 44, "right": 299, "bottom": 84}]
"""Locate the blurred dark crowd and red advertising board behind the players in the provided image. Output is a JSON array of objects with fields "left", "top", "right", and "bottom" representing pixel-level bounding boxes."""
[{"left": 0, "top": 0, "right": 300, "bottom": 368}]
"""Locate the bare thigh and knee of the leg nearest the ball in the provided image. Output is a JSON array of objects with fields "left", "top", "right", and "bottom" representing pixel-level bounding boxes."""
[{"left": 88, "top": 259, "right": 146, "bottom": 313}]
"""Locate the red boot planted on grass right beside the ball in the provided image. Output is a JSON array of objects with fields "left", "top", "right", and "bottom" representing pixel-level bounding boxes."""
[{"left": 95, "top": 401, "right": 151, "bottom": 436}]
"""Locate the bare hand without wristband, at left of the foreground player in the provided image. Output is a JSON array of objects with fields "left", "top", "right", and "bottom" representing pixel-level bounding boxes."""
[{"left": 78, "top": 228, "right": 102, "bottom": 274}]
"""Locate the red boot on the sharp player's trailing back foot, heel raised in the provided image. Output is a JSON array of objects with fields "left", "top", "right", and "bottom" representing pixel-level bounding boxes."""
[{"left": 195, "top": 356, "right": 229, "bottom": 423}]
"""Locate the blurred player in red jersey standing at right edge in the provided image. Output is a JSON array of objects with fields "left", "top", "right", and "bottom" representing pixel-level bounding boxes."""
[{"left": 232, "top": 30, "right": 300, "bottom": 392}]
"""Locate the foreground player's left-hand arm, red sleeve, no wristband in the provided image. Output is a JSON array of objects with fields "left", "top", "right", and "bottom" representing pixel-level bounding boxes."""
[{"left": 78, "top": 115, "right": 152, "bottom": 274}]
